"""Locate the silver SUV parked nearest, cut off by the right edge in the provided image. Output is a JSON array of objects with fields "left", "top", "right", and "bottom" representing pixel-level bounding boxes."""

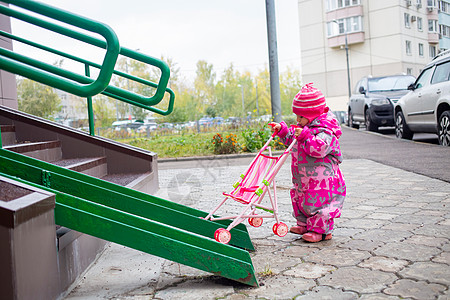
[{"left": 395, "top": 50, "right": 450, "bottom": 146}]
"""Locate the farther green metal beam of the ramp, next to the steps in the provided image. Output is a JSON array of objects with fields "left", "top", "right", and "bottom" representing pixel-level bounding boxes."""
[{"left": 0, "top": 149, "right": 254, "bottom": 250}]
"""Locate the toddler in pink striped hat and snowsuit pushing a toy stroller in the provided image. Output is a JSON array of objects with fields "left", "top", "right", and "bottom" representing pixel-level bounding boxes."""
[{"left": 273, "top": 83, "right": 346, "bottom": 242}]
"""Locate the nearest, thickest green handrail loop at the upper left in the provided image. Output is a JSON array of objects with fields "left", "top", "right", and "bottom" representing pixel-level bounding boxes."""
[{"left": 0, "top": 0, "right": 120, "bottom": 97}]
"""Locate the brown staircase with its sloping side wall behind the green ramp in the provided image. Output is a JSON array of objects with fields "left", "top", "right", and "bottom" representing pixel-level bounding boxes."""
[{"left": 0, "top": 106, "right": 158, "bottom": 193}]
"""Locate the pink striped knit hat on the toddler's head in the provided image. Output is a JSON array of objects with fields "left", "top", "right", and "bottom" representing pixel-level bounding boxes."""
[{"left": 292, "top": 83, "right": 326, "bottom": 121}]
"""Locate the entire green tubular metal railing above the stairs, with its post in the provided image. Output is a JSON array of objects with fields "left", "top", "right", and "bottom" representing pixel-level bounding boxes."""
[{"left": 0, "top": 0, "right": 175, "bottom": 135}]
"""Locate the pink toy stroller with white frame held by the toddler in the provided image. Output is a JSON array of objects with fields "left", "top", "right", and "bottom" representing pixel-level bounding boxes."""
[{"left": 205, "top": 124, "right": 296, "bottom": 244}]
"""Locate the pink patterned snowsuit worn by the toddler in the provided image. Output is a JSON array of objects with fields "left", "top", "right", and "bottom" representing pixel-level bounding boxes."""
[{"left": 278, "top": 109, "right": 346, "bottom": 234}]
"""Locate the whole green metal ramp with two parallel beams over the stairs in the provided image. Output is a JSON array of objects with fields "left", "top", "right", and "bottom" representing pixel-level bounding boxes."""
[{"left": 0, "top": 149, "right": 258, "bottom": 286}]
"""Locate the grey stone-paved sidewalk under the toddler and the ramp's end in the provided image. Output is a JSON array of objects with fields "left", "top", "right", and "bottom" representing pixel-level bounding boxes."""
[{"left": 66, "top": 159, "right": 450, "bottom": 300}]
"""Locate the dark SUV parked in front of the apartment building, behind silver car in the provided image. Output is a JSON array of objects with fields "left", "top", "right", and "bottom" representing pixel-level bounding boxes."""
[{"left": 347, "top": 75, "right": 415, "bottom": 131}]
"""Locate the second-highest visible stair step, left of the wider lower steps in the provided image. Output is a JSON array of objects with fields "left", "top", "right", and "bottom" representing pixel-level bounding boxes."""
[{"left": 3, "top": 141, "right": 62, "bottom": 162}]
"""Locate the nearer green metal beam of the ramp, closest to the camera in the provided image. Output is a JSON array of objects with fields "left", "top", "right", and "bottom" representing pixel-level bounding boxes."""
[{"left": 0, "top": 172, "right": 258, "bottom": 286}]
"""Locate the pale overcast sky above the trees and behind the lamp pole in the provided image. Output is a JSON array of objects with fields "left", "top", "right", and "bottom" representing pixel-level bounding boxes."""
[{"left": 8, "top": 0, "right": 300, "bottom": 79}]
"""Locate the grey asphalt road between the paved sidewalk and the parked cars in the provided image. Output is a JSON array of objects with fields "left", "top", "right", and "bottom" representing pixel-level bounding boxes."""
[{"left": 340, "top": 125, "right": 450, "bottom": 182}]
